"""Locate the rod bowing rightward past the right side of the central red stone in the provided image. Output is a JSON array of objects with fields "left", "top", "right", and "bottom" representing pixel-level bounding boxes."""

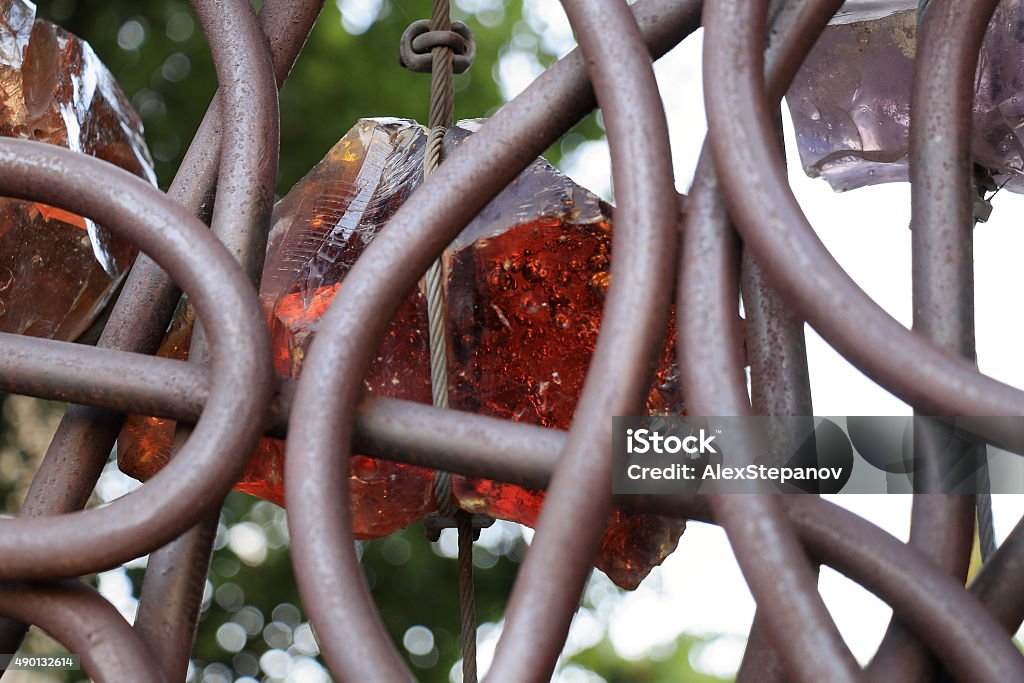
[{"left": 487, "top": 0, "right": 678, "bottom": 683}]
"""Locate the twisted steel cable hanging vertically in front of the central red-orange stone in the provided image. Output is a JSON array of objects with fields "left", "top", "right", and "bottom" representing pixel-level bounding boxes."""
[{"left": 423, "top": 0, "right": 477, "bottom": 683}]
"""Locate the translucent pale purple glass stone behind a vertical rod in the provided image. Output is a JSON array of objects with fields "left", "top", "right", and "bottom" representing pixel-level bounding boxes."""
[{"left": 786, "top": 0, "right": 1024, "bottom": 193}]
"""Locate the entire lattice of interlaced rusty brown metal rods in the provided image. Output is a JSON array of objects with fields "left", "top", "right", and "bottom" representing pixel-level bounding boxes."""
[{"left": 0, "top": 0, "right": 1024, "bottom": 683}]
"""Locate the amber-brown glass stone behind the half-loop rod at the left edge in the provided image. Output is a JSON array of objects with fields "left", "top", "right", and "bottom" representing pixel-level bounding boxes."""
[{"left": 0, "top": 0, "right": 156, "bottom": 340}]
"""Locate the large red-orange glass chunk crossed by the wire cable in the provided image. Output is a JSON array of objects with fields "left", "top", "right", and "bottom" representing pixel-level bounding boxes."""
[{"left": 119, "top": 119, "right": 683, "bottom": 588}]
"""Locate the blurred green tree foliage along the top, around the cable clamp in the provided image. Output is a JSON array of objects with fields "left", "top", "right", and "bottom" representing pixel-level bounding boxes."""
[{"left": 39, "top": 0, "right": 601, "bottom": 196}]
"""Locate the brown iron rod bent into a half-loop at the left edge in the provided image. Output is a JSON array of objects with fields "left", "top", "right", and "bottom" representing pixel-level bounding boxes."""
[{"left": 0, "top": 139, "right": 272, "bottom": 581}]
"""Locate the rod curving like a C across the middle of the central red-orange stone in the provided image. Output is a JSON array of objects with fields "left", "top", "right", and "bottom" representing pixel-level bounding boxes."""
[{"left": 285, "top": 2, "right": 697, "bottom": 681}]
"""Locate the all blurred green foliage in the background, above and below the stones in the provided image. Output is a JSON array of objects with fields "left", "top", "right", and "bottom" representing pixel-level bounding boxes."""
[{"left": 0, "top": 0, "right": 719, "bottom": 683}]
